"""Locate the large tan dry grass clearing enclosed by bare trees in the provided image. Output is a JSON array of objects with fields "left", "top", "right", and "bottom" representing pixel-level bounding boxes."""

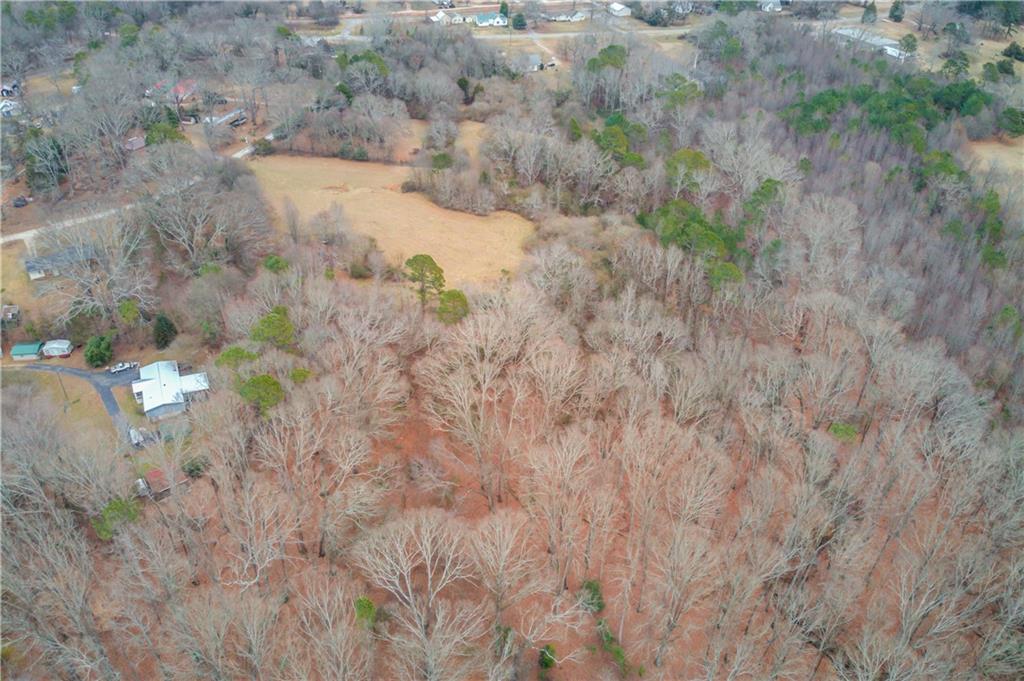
[{"left": 250, "top": 155, "right": 534, "bottom": 285}]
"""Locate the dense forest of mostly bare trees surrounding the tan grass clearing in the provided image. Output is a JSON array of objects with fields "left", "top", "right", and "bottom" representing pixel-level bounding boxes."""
[{"left": 0, "top": 2, "right": 1024, "bottom": 681}]
